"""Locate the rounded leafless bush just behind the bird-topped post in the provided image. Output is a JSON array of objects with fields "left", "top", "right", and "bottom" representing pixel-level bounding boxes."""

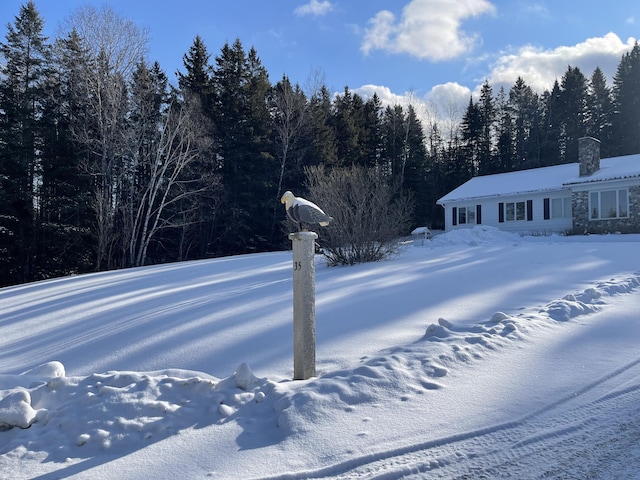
[{"left": 305, "top": 166, "right": 413, "bottom": 266}]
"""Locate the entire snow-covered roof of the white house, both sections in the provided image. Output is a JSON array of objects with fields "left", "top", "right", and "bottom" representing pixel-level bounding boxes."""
[{"left": 436, "top": 154, "right": 640, "bottom": 205}]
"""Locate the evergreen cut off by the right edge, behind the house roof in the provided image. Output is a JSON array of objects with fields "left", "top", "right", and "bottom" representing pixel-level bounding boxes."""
[{"left": 612, "top": 42, "right": 640, "bottom": 155}]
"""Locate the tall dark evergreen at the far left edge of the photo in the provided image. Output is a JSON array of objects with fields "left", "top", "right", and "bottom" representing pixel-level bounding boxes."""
[{"left": 0, "top": 1, "right": 50, "bottom": 285}]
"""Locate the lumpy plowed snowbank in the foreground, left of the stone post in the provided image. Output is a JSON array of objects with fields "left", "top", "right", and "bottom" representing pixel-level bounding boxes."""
[{"left": 0, "top": 362, "right": 275, "bottom": 460}]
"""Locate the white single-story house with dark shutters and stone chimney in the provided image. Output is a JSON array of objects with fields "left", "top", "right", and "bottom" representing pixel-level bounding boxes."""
[{"left": 436, "top": 137, "right": 640, "bottom": 234}]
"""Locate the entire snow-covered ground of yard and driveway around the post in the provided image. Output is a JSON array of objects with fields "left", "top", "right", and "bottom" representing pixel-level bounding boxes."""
[{"left": 0, "top": 227, "right": 640, "bottom": 480}]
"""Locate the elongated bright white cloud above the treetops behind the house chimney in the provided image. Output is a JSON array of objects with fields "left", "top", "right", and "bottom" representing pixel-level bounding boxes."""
[{"left": 488, "top": 33, "right": 636, "bottom": 92}]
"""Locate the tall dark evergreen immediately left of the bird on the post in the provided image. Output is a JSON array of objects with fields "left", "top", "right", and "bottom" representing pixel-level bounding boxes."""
[{"left": 213, "top": 39, "right": 278, "bottom": 254}]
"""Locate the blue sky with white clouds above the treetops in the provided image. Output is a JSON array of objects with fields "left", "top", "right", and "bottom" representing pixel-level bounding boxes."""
[{"left": 0, "top": 0, "right": 640, "bottom": 117}]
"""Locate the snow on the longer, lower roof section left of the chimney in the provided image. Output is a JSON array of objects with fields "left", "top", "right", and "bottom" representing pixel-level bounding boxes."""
[{"left": 436, "top": 163, "right": 579, "bottom": 204}]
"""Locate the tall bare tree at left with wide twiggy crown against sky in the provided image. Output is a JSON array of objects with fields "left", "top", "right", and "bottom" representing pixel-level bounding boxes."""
[{"left": 64, "top": 6, "right": 148, "bottom": 270}]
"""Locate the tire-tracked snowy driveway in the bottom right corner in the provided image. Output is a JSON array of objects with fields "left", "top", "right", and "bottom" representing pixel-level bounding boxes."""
[{"left": 269, "top": 358, "right": 640, "bottom": 480}]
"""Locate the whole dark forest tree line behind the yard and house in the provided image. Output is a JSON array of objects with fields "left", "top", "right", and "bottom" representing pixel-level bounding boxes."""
[{"left": 0, "top": 1, "right": 640, "bottom": 285}]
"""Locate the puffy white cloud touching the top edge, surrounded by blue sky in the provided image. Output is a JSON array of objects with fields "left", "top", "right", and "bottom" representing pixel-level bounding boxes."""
[{"left": 360, "top": 0, "right": 495, "bottom": 61}]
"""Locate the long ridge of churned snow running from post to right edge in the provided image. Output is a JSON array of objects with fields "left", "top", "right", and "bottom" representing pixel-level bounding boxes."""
[{"left": 275, "top": 275, "right": 640, "bottom": 434}]
